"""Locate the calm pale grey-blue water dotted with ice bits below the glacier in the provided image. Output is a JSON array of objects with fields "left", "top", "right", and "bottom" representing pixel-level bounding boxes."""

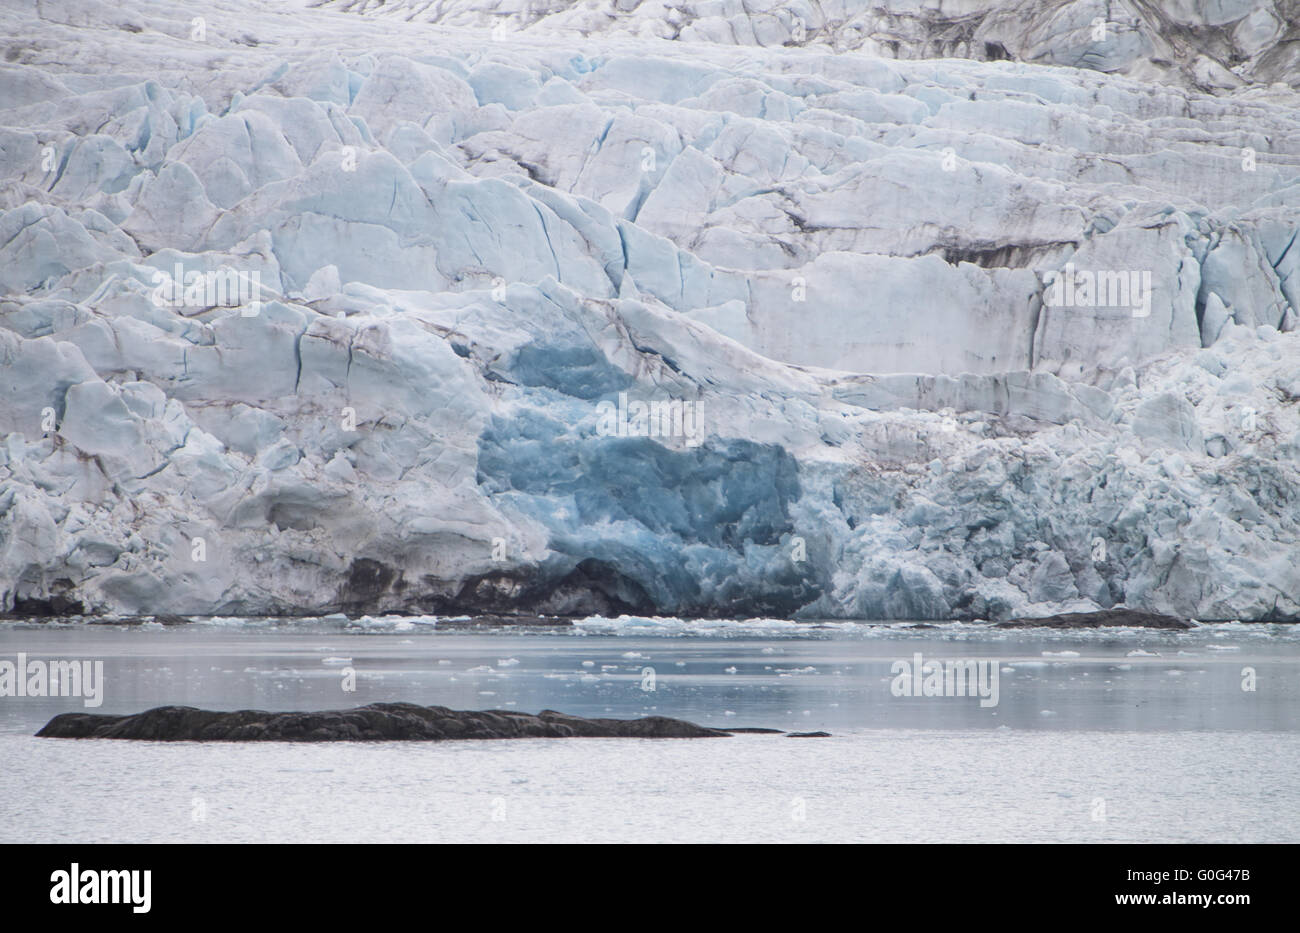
[{"left": 0, "top": 619, "right": 1300, "bottom": 842}]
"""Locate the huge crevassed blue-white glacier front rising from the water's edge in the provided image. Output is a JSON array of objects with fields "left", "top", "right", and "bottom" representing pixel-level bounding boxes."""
[{"left": 0, "top": 0, "right": 1300, "bottom": 619}]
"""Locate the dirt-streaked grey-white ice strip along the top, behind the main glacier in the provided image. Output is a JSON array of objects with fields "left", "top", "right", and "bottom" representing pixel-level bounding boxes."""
[{"left": 312, "top": 0, "right": 1300, "bottom": 91}]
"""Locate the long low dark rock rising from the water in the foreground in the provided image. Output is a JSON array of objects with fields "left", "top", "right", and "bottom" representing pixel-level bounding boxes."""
[{"left": 36, "top": 703, "right": 729, "bottom": 742}]
